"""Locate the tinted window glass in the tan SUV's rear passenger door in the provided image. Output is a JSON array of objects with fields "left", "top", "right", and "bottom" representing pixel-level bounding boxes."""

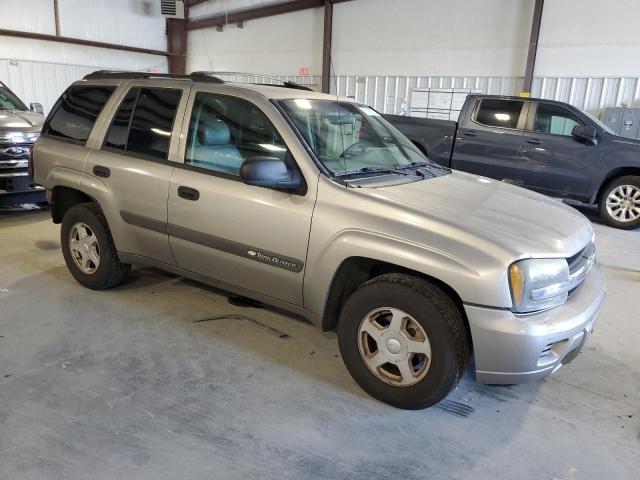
[{"left": 105, "top": 88, "right": 182, "bottom": 160}]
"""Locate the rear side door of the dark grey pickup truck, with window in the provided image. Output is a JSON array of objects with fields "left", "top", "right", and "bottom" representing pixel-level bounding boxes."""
[{"left": 451, "top": 98, "right": 529, "bottom": 185}]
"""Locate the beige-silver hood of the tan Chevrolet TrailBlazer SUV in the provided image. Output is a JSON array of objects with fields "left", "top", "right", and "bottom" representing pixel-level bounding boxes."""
[{"left": 372, "top": 171, "right": 593, "bottom": 259}]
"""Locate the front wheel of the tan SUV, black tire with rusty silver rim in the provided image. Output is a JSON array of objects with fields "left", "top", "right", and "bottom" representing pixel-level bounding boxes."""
[{"left": 338, "top": 273, "right": 470, "bottom": 410}]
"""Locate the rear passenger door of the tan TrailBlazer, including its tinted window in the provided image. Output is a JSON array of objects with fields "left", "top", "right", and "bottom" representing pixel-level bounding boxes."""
[{"left": 83, "top": 80, "right": 191, "bottom": 264}]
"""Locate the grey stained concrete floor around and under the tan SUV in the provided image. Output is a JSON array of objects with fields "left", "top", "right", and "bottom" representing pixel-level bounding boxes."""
[{"left": 0, "top": 204, "right": 640, "bottom": 480}]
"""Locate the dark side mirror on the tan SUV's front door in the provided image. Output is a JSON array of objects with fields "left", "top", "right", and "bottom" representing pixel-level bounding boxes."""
[{"left": 240, "top": 157, "right": 300, "bottom": 190}]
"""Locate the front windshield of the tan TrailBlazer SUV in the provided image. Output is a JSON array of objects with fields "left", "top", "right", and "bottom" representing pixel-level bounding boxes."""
[{"left": 279, "top": 98, "right": 428, "bottom": 176}]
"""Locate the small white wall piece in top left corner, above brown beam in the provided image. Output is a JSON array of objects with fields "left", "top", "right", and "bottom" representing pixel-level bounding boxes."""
[{"left": 0, "top": 0, "right": 56, "bottom": 35}]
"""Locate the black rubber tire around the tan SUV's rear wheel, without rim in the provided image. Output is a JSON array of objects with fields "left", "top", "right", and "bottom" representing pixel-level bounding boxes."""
[{"left": 60, "top": 204, "right": 119, "bottom": 290}]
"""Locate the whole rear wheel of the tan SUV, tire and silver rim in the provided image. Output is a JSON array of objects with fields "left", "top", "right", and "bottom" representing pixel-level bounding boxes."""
[{"left": 60, "top": 203, "right": 131, "bottom": 290}]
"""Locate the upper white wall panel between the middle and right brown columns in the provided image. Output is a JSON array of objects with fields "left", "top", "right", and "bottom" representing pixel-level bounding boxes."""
[{"left": 333, "top": 0, "right": 533, "bottom": 76}]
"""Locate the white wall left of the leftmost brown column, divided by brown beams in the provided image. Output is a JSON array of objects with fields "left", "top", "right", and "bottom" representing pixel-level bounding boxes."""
[{"left": 0, "top": 0, "right": 167, "bottom": 111}]
